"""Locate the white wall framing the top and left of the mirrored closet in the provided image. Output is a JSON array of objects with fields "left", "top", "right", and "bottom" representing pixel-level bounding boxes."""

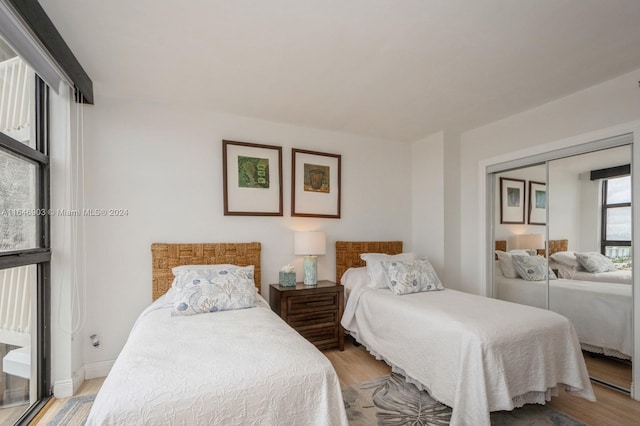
[{"left": 456, "top": 70, "right": 640, "bottom": 294}]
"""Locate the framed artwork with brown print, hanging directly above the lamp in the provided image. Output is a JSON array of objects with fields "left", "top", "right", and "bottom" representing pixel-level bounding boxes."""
[{"left": 291, "top": 148, "right": 342, "bottom": 218}]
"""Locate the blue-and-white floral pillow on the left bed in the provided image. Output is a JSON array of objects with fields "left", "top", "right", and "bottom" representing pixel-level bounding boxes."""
[{"left": 171, "top": 266, "right": 257, "bottom": 316}]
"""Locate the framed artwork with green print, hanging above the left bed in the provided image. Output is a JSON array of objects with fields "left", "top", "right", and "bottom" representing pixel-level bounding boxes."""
[{"left": 222, "top": 140, "right": 282, "bottom": 216}]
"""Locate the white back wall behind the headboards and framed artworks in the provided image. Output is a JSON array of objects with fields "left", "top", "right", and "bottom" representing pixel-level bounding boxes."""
[{"left": 77, "top": 97, "right": 412, "bottom": 366}]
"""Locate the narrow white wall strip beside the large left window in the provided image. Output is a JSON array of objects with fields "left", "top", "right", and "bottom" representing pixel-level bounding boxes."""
[{"left": 49, "top": 88, "right": 86, "bottom": 398}]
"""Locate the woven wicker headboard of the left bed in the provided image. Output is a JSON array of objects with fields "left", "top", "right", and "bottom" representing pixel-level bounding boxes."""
[{"left": 151, "top": 243, "right": 260, "bottom": 300}]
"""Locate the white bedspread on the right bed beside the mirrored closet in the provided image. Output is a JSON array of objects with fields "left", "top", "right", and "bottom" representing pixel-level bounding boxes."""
[{"left": 342, "top": 287, "right": 595, "bottom": 425}]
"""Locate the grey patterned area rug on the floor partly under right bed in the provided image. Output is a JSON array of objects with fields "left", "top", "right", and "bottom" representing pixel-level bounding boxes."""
[{"left": 342, "top": 373, "right": 584, "bottom": 426}]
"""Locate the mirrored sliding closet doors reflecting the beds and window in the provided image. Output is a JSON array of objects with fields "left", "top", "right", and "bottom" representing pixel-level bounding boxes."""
[{"left": 492, "top": 145, "right": 633, "bottom": 393}]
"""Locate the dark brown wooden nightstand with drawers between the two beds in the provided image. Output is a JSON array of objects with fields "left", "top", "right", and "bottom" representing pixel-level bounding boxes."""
[{"left": 269, "top": 281, "right": 344, "bottom": 351}]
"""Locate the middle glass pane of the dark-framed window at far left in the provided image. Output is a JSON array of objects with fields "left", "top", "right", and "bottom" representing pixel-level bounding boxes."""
[{"left": 0, "top": 150, "right": 36, "bottom": 251}]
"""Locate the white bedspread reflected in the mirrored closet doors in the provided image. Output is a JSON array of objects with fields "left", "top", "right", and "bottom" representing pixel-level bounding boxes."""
[{"left": 494, "top": 274, "right": 633, "bottom": 359}]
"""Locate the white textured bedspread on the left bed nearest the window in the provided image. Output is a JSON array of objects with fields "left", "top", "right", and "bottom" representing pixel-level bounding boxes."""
[{"left": 86, "top": 298, "right": 347, "bottom": 426}]
